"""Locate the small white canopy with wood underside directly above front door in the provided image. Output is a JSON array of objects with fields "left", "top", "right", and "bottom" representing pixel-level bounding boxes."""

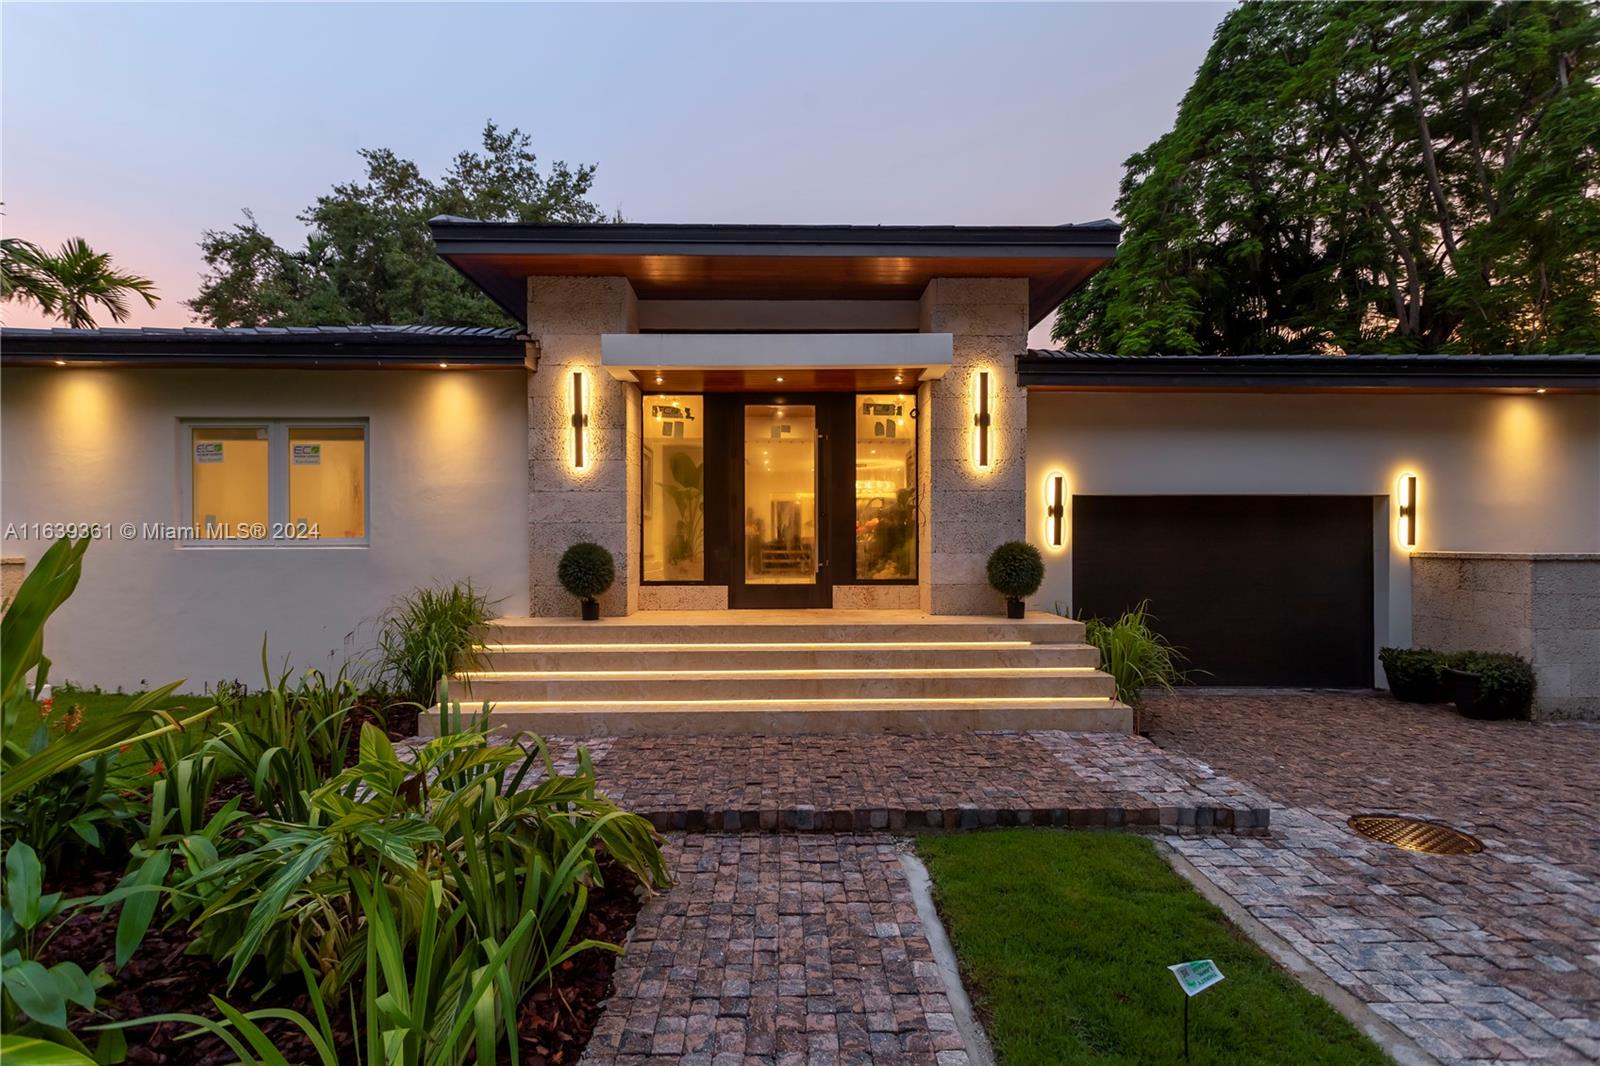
[{"left": 600, "top": 333, "right": 954, "bottom": 392}]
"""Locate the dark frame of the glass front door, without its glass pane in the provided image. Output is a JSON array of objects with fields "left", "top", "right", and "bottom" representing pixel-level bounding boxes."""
[{"left": 720, "top": 392, "right": 856, "bottom": 610}]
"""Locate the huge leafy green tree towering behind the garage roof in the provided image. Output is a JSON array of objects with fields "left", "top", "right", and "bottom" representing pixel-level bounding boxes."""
[{"left": 1054, "top": 0, "right": 1600, "bottom": 355}]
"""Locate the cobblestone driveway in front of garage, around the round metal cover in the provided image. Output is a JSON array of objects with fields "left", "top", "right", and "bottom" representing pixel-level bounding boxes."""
[{"left": 1146, "top": 693, "right": 1600, "bottom": 1063}]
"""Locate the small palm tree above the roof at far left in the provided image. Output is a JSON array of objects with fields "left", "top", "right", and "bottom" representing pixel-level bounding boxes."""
[{"left": 0, "top": 237, "right": 160, "bottom": 330}]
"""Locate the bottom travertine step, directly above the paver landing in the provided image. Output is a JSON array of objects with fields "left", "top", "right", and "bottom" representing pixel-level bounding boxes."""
[{"left": 419, "top": 696, "right": 1133, "bottom": 736}]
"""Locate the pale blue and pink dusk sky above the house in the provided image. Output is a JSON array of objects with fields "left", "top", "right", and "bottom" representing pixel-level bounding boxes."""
[{"left": 0, "top": 3, "right": 1229, "bottom": 340}]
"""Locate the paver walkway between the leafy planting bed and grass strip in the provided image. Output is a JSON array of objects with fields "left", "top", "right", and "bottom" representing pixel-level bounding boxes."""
[{"left": 584, "top": 834, "right": 968, "bottom": 1066}]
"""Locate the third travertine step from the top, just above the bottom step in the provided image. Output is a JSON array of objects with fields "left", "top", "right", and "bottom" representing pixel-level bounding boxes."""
[{"left": 453, "top": 666, "right": 1115, "bottom": 703}]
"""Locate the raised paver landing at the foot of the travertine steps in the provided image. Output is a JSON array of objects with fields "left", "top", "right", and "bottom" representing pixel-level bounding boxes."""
[{"left": 505, "top": 730, "right": 1269, "bottom": 834}]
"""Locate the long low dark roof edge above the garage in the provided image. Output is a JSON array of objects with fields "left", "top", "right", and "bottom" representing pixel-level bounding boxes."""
[{"left": 1016, "top": 347, "right": 1600, "bottom": 392}]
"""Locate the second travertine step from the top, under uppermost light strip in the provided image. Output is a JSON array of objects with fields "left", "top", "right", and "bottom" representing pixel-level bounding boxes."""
[{"left": 478, "top": 640, "right": 1099, "bottom": 671}]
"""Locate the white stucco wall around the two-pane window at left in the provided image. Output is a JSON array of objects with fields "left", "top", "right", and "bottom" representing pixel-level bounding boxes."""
[{"left": 0, "top": 368, "right": 528, "bottom": 690}]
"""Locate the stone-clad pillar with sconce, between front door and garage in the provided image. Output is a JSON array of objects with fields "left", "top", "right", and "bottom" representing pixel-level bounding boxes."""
[{"left": 917, "top": 277, "right": 1027, "bottom": 615}]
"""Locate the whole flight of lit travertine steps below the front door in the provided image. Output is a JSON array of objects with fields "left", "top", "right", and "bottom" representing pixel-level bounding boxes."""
[{"left": 422, "top": 610, "right": 1133, "bottom": 736}]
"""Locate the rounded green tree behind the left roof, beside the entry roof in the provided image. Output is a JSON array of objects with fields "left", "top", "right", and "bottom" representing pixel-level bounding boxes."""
[{"left": 189, "top": 122, "right": 606, "bottom": 327}]
